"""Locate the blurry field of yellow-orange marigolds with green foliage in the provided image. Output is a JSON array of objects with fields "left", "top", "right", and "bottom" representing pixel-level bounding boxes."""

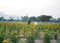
[{"left": 0, "top": 22, "right": 60, "bottom": 43}]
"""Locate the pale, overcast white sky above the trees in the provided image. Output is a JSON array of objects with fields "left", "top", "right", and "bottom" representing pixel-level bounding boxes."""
[{"left": 0, "top": 0, "right": 60, "bottom": 18}]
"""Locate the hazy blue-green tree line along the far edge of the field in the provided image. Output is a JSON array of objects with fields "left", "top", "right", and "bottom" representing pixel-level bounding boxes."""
[{"left": 0, "top": 15, "right": 60, "bottom": 22}]
